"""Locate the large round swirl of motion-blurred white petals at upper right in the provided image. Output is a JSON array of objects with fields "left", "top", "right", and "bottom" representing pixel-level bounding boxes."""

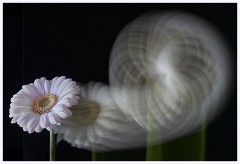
[{"left": 109, "top": 11, "right": 231, "bottom": 144}]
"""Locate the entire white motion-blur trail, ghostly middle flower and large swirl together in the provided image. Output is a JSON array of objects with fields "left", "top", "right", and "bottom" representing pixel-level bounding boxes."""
[{"left": 54, "top": 11, "right": 231, "bottom": 151}]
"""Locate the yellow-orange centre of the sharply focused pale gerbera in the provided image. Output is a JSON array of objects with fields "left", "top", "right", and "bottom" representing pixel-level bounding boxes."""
[{"left": 32, "top": 94, "right": 57, "bottom": 114}]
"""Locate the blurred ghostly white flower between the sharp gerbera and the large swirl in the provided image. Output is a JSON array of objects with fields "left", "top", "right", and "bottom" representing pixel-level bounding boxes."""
[{"left": 53, "top": 82, "right": 146, "bottom": 151}]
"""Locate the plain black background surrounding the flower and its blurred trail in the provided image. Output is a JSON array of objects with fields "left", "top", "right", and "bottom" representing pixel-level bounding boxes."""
[{"left": 3, "top": 3, "right": 237, "bottom": 161}]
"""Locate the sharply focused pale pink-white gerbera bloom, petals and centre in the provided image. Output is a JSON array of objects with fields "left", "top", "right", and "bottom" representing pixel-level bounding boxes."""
[{"left": 9, "top": 76, "right": 80, "bottom": 133}]
